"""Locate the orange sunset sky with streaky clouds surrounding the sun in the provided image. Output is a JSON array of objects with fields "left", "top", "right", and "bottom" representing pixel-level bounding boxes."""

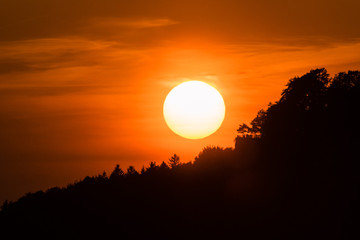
[{"left": 0, "top": 0, "right": 360, "bottom": 201}]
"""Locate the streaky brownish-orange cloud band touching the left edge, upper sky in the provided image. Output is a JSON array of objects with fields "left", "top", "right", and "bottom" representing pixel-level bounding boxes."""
[{"left": 0, "top": 38, "right": 111, "bottom": 74}]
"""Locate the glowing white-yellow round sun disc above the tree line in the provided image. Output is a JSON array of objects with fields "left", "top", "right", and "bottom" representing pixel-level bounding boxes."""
[{"left": 163, "top": 81, "right": 225, "bottom": 139}]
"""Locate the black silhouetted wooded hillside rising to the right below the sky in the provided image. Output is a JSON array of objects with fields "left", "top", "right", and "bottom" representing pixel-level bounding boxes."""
[{"left": 0, "top": 69, "right": 360, "bottom": 239}]
